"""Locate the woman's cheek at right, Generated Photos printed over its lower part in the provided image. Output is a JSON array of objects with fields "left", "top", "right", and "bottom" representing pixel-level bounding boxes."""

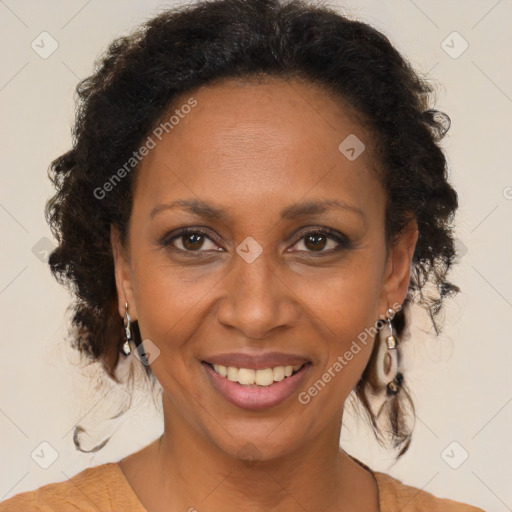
[{"left": 295, "top": 251, "right": 383, "bottom": 400}]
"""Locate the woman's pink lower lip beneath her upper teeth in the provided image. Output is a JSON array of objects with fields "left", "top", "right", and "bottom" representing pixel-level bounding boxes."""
[{"left": 202, "top": 363, "right": 311, "bottom": 411}]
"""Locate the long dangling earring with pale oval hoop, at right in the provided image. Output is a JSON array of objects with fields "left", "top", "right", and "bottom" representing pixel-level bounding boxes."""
[{"left": 375, "top": 309, "right": 403, "bottom": 397}]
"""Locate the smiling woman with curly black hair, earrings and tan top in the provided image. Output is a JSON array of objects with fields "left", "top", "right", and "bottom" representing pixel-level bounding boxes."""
[{"left": 0, "top": 0, "right": 486, "bottom": 512}]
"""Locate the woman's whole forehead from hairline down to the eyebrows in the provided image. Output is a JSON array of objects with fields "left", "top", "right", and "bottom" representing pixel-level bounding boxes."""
[{"left": 137, "top": 79, "right": 382, "bottom": 217}]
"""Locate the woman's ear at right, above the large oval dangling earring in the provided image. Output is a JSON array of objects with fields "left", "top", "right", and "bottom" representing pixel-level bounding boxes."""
[{"left": 381, "top": 219, "right": 418, "bottom": 312}]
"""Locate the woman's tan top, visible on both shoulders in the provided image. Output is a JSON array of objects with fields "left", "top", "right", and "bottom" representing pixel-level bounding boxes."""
[{"left": 0, "top": 462, "right": 485, "bottom": 512}]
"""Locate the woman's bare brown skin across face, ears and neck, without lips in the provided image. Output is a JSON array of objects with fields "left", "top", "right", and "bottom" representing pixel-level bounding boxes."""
[{"left": 112, "top": 79, "right": 418, "bottom": 512}]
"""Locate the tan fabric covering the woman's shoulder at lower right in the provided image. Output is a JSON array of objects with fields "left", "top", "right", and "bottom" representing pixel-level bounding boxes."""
[{"left": 373, "top": 471, "right": 485, "bottom": 512}]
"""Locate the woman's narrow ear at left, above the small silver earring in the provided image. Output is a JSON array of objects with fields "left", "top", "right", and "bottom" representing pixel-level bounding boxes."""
[{"left": 110, "top": 226, "right": 137, "bottom": 321}]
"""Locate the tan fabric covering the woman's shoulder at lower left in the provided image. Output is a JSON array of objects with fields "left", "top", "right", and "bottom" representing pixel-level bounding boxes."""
[{"left": 0, "top": 463, "right": 145, "bottom": 512}]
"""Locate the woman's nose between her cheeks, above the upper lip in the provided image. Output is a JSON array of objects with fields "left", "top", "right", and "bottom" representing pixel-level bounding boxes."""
[{"left": 217, "top": 251, "right": 300, "bottom": 339}]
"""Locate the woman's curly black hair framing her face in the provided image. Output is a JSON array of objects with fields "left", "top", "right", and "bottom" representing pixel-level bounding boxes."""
[{"left": 46, "top": 0, "right": 458, "bottom": 454}]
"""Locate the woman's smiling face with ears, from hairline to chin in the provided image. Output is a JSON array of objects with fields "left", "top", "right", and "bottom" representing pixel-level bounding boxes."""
[{"left": 114, "top": 80, "right": 416, "bottom": 459}]
